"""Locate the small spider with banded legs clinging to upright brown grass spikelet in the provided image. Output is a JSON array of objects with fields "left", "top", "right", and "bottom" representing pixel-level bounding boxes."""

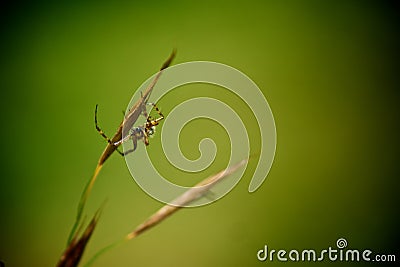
[{"left": 94, "top": 103, "right": 164, "bottom": 156}]
